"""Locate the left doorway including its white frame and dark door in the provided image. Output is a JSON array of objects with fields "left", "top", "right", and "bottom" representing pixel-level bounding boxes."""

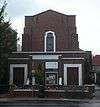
[{"left": 9, "top": 64, "right": 28, "bottom": 86}]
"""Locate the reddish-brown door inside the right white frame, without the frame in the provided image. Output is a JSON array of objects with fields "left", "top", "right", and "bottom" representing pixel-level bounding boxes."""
[{"left": 67, "top": 67, "right": 79, "bottom": 85}]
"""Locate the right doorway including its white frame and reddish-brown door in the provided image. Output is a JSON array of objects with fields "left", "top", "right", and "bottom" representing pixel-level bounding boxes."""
[{"left": 64, "top": 64, "right": 82, "bottom": 85}]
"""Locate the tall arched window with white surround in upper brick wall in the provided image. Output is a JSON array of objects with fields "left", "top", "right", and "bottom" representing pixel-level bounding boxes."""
[{"left": 44, "top": 31, "right": 55, "bottom": 52}]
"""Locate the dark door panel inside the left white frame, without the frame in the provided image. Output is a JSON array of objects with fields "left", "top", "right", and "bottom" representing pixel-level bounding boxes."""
[{"left": 13, "top": 67, "right": 24, "bottom": 86}]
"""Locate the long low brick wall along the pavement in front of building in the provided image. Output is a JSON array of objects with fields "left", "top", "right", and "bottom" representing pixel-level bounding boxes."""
[{"left": 11, "top": 85, "right": 94, "bottom": 98}]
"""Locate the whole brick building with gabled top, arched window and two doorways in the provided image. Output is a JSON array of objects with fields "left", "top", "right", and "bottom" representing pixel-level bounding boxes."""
[{"left": 9, "top": 10, "right": 92, "bottom": 98}]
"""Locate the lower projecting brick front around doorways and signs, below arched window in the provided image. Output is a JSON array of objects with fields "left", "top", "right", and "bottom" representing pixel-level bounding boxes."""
[{"left": 9, "top": 51, "right": 91, "bottom": 84}]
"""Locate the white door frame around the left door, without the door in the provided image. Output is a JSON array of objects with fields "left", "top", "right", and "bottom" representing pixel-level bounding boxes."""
[{"left": 9, "top": 64, "right": 28, "bottom": 84}]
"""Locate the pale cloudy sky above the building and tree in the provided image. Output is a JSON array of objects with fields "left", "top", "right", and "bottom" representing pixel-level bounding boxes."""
[{"left": 0, "top": 0, "right": 100, "bottom": 55}]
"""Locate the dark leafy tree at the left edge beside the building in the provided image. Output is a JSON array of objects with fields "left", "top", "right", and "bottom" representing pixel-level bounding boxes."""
[{"left": 0, "top": 2, "right": 17, "bottom": 84}]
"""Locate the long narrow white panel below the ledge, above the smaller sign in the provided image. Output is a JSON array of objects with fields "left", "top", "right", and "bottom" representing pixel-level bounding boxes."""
[{"left": 32, "top": 55, "right": 59, "bottom": 60}]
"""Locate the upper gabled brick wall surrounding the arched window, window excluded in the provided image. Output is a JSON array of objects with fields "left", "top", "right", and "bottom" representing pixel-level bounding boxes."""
[{"left": 22, "top": 10, "right": 79, "bottom": 52}]
